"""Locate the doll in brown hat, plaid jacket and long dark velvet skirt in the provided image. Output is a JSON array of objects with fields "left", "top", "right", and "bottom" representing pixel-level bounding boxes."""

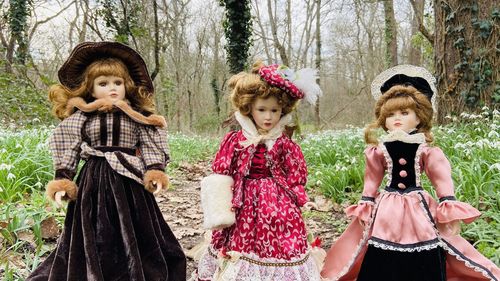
[{"left": 27, "top": 42, "right": 186, "bottom": 281}]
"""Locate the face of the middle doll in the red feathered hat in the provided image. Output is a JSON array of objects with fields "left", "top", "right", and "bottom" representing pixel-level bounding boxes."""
[{"left": 251, "top": 96, "right": 282, "bottom": 131}]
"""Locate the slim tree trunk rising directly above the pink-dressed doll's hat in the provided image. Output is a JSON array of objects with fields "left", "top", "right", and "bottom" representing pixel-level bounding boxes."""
[{"left": 383, "top": 0, "right": 398, "bottom": 67}]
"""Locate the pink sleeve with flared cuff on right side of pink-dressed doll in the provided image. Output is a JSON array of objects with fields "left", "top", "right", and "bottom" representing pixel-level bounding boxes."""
[{"left": 421, "top": 147, "right": 481, "bottom": 223}]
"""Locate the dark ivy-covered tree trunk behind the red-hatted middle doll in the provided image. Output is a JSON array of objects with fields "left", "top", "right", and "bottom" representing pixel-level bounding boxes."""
[{"left": 219, "top": 0, "right": 252, "bottom": 73}]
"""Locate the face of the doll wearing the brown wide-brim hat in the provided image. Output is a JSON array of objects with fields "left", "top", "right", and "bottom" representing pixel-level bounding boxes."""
[{"left": 92, "top": 75, "right": 125, "bottom": 101}]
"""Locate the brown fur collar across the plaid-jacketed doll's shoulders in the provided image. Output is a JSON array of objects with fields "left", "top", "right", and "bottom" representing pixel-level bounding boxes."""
[{"left": 66, "top": 97, "right": 167, "bottom": 128}]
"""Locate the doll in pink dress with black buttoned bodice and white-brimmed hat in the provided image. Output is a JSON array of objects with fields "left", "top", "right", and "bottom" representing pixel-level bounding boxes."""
[{"left": 321, "top": 65, "right": 500, "bottom": 281}]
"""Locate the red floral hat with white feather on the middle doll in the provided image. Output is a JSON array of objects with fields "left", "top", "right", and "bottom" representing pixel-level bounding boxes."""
[{"left": 259, "top": 64, "right": 323, "bottom": 104}]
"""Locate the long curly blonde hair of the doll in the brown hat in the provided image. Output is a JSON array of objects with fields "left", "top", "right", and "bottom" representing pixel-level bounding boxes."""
[{"left": 49, "top": 58, "right": 155, "bottom": 120}]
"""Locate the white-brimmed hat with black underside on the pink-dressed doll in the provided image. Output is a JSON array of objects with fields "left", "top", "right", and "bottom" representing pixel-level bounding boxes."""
[{"left": 371, "top": 64, "right": 437, "bottom": 111}]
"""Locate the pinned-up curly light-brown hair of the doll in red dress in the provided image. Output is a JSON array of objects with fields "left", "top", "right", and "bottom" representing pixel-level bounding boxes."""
[{"left": 228, "top": 61, "right": 299, "bottom": 117}]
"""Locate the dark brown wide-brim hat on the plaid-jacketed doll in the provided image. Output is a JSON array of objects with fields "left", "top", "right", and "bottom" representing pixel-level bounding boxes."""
[{"left": 57, "top": 41, "right": 154, "bottom": 94}]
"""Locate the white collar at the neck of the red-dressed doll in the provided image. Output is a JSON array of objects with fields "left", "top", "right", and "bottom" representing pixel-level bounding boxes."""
[{"left": 234, "top": 111, "right": 292, "bottom": 150}]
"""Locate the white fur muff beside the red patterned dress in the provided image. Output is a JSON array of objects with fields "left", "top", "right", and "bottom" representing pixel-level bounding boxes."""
[{"left": 201, "top": 174, "right": 236, "bottom": 229}]
